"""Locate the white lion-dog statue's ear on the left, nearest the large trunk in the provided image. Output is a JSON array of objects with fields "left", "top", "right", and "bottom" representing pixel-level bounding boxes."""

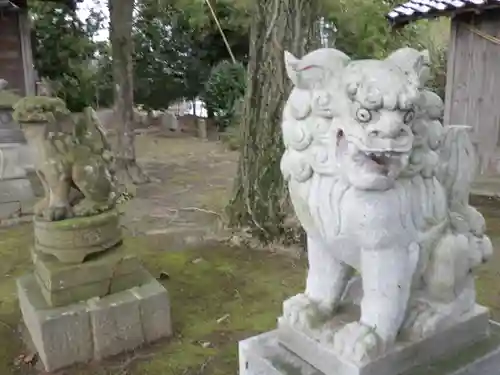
[{"left": 285, "top": 48, "right": 350, "bottom": 90}]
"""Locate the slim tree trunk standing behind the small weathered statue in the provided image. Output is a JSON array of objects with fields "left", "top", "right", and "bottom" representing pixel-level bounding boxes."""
[{"left": 108, "top": 0, "right": 149, "bottom": 184}]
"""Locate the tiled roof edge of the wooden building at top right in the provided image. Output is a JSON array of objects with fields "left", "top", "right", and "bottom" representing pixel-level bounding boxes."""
[{"left": 386, "top": 0, "right": 500, "bottom": 26}]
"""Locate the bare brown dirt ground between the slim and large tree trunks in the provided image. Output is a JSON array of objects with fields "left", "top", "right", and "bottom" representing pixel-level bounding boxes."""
[{"left": 117, "top": 131, "right": 237, "bottom": 243}]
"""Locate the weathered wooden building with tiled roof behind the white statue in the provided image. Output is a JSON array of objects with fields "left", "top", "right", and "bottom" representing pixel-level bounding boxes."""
[{"left": 387, "top": 0, "right": 500, "bottom": 177}]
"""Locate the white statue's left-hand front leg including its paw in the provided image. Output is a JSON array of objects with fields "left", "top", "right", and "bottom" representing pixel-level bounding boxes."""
[{"left": 283, "top": 237, "right": 354, "bottom": 327}]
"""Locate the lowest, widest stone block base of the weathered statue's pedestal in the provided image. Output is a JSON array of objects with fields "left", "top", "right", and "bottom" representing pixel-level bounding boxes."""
[{"left": 17, "top": 274, "right": 172, "bottom": 371}]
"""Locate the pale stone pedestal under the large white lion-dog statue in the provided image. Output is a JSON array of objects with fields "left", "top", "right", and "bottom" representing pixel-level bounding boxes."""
[{"left": 239, "top": 306, "right": 500, "bottom": 375}]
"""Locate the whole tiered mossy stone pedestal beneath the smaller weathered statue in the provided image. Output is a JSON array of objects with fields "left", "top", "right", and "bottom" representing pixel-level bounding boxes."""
[{"left": 17, "top": 211, "right": 172, "bottom": 371}]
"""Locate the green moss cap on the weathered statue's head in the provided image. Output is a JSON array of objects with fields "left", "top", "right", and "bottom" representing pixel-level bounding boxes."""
[{"left": 13, "top": 96, "right": 69, "bottom": 123}]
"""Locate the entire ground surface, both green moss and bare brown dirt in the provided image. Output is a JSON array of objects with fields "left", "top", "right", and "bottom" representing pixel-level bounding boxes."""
[{"left": 0, "top": 131, "right": 500, "bottom": 375}]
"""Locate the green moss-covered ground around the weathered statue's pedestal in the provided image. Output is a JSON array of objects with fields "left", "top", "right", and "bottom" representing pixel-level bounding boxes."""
[{"left": 0, "top": 225, "right": 305, "bottom": 375}]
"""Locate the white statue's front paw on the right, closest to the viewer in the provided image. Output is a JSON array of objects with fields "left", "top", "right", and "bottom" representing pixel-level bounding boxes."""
[{"left": 333, "top": 322, "right": 385, "bottom": 363}]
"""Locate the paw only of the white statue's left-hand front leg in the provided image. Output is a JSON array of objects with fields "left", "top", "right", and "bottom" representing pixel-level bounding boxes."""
[{"left": 283, "top": 293, "right": 327, "bottom": 329}]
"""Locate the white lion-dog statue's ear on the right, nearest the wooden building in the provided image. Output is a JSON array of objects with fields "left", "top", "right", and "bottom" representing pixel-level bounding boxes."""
[{"left": 386, "top": 47, "right": 431, "bottom": 87}]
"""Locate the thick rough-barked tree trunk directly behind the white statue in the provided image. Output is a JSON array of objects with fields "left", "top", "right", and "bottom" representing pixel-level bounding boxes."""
[{"left": 228, "top": 0, "right": 320, "bottom": 243}]
